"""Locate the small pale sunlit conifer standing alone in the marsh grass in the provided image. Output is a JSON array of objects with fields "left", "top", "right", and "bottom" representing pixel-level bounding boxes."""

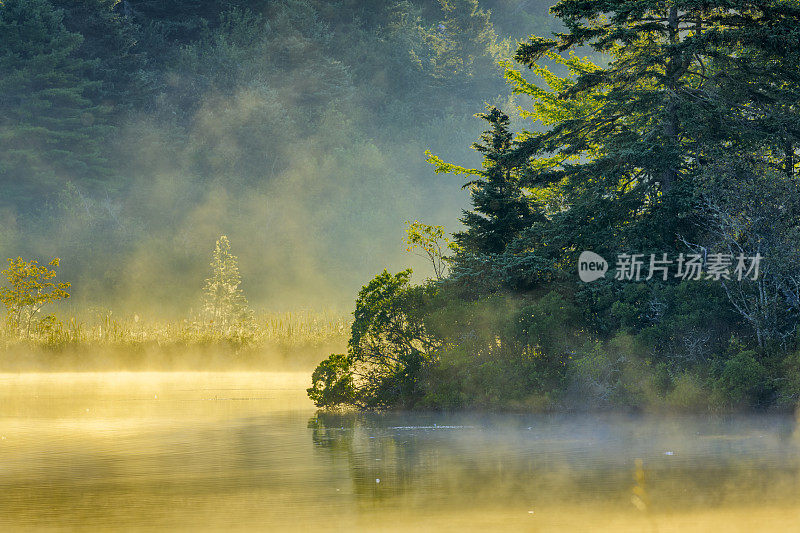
[{"left": 203, "top": 235, "right": 250, "bottom": 331}]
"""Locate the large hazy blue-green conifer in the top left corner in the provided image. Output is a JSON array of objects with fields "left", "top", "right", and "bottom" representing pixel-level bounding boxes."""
[{"left": 0, "top": 0, "right": 109, "bottom": 206}]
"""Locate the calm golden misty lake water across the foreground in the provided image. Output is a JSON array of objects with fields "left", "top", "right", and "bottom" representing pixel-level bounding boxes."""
[{"left": 0, "top": 373, "right": 800, "bottom": 531}]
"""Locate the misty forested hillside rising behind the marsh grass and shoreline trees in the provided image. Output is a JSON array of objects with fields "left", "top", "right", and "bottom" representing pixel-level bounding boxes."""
[{"left": 0, "top": 0, "right": 557, "bottom": 314}]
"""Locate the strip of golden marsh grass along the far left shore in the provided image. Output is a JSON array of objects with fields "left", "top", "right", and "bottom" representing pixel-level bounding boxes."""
[{"left": 0, "top": 310, "right": 351, "bottom": 371}]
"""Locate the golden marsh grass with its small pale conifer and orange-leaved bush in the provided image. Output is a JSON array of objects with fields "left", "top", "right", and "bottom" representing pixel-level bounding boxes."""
[{"left": 0, "top": 235, "right": 350, "bottom": 370}]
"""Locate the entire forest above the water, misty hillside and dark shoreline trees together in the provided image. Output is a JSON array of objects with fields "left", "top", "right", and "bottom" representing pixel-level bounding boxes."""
[{"left": 0, "top": 0, "right": 800, "bottom": 411}]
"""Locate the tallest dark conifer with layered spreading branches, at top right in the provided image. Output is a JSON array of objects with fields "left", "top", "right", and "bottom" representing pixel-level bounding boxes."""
[{"left": 504, "top": 0, "right": 800, "bottom": 260}]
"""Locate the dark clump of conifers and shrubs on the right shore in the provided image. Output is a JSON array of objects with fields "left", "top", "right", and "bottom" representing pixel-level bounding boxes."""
[{"left": 309, "top": 0, "right": 800, "bottom": 409}]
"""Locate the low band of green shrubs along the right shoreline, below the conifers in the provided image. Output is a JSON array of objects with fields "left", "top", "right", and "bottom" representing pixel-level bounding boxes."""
[{"left": 309, "top": 271, "right": 800, "bottom": 412}]
